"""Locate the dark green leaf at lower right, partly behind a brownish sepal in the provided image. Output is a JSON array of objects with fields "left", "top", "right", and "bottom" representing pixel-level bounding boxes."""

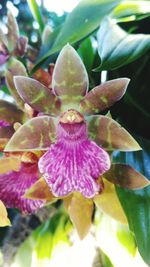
[{"left": 114, "top": 140, "right": 150, "bottom": 266}]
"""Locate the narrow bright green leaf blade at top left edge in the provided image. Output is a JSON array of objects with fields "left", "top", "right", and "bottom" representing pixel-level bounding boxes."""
[{"left": 27, "top": 0, "right": 44, "bottom": 33}]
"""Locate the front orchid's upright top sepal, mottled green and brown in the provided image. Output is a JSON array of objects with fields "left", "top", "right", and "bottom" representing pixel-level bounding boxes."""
[{"left": 52, "top": 44, "right": 89, "bottom": 103}]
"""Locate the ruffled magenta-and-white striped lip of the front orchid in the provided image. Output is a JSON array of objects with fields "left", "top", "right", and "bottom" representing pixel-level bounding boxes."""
[{"left": 39, "top": 122, "right": 110, "bottom": 198}]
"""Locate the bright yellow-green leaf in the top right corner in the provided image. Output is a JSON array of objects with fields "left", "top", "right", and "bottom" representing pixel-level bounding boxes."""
[{"left": 111, "top": 1, "right": 150, "bottom": 22}]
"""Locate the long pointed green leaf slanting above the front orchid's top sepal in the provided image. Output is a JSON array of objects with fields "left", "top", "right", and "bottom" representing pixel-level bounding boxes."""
[{"left": 32, "top": 0, "right": 121, "bottom": 69}]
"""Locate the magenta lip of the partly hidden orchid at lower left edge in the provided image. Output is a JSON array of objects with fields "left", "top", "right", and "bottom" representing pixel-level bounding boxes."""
[{"left": 0, "top": 163, "right": 44, "bottom": 213}]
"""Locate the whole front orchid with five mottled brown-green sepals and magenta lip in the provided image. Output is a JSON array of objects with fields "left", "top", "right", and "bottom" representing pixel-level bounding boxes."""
[{"left": 5, "top": 45, "right": 140, "bottom": 210}]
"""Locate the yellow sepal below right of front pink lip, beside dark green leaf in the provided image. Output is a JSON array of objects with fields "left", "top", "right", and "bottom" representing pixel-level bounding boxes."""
[{"left": 94, "top": 178, "right": 127, "bottom": 224}]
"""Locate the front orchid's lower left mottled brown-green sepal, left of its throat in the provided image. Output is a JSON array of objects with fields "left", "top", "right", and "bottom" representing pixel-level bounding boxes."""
[{"left": 5, "top": 116, "right": 56, "bottom": 152}]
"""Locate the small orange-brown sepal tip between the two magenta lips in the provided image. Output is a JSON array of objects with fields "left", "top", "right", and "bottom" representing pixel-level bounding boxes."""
[{"left": 25, "top": 178, "right": 57, "bottom": 202}]
